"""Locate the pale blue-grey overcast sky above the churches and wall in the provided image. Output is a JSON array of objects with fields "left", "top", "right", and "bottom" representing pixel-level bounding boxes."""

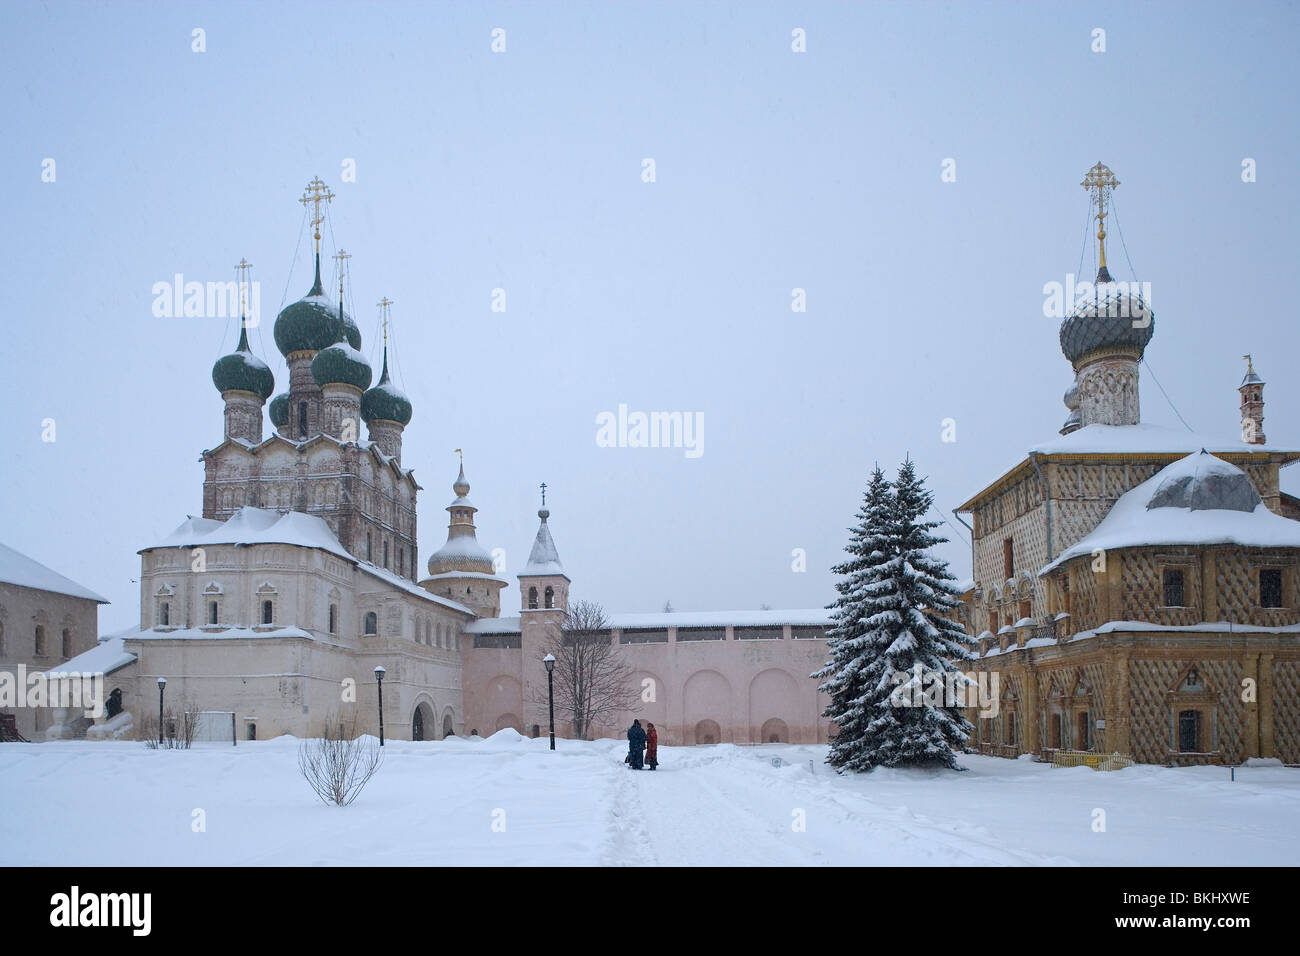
[{"left": 0, "top": 3, "right": 1300, "bottom": 632}]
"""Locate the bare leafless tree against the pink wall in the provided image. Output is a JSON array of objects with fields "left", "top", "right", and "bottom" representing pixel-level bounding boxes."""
[{"left": 534, "top": 601, "right": 636, "bottom": 740}]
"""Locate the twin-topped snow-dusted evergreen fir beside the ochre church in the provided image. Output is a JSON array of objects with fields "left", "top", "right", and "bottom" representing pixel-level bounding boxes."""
[{"left": 814, "top": 459, "right": 974, "bottom": 770}]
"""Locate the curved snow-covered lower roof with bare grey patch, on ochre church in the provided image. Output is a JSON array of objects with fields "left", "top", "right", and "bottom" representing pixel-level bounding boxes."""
[{"left": 1039, "top": 451, "right": 1300, "bottom": 575}]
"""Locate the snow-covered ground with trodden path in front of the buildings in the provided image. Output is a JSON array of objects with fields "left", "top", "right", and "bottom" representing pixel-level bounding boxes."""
[{"left": 0, "top": 731, "right": 1300, "bottom": 866}]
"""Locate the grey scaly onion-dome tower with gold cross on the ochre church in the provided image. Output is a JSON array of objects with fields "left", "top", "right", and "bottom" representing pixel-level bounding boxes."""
[{"left": 1061, "top": 163, "right": 1156, "bottom": 434}]
